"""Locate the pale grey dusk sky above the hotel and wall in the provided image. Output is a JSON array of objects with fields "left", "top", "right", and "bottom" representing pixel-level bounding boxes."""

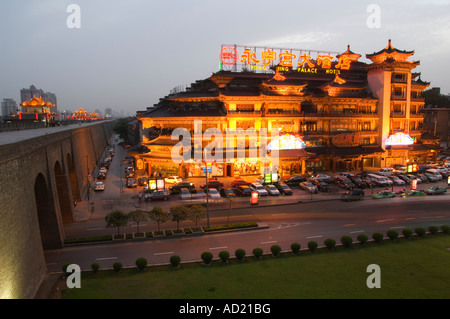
[{"left": 0, "top": 0, "right": 450, "bottom": 115}]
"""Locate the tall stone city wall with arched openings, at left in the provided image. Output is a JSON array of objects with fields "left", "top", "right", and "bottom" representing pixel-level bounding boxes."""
[{"left": 0, "top": 121, "right": 114, "bottom": 299}]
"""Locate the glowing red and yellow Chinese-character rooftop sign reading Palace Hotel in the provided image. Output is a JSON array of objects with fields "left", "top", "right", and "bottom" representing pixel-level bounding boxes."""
[{"left": 220, "top": 45, "right": 353, "bottom": 74}]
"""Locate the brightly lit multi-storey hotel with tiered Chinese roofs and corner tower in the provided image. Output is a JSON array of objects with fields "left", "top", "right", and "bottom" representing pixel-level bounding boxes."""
[{"left": 130, "top": 40, "right": 436, "bottom": 177}]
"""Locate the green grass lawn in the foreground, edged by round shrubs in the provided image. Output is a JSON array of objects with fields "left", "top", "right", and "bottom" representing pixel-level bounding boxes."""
[{"left": 62, "top": 233, "right": 450, "bottom": 299}]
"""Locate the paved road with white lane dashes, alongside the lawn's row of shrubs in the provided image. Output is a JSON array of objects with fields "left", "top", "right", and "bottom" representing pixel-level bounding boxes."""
[{"left": 45, "top": 197, "right": 450, "bottom": 272}]
